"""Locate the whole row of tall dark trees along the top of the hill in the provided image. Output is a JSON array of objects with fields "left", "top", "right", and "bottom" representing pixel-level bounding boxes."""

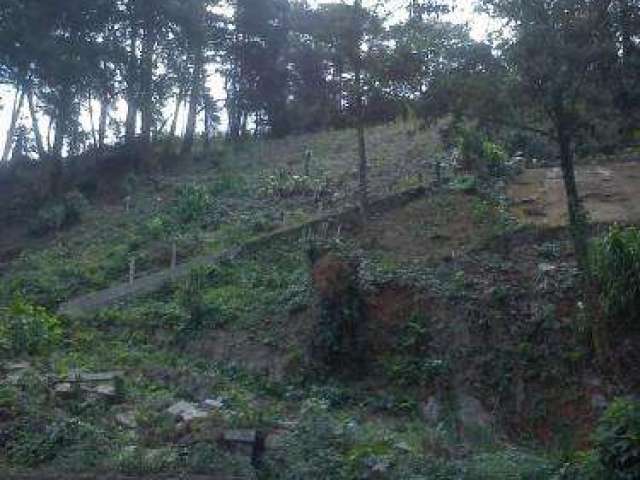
[{"left": 0, "top": 0, "right": 640, "bottom": 221}]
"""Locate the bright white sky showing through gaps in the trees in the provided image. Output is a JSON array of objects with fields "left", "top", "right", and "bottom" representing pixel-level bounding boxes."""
[{"left": 0, "top": 0, "right": 493, "bottom": 154}]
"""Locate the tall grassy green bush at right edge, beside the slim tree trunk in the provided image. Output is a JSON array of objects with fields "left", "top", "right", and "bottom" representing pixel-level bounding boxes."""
[{"left": 591, "top": 225, "right": 640, "bottom": 328}]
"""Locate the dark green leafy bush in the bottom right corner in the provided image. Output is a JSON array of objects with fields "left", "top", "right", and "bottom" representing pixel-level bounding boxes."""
[{"left": 594, "top": 399, "right": 640, "bottom": 480}]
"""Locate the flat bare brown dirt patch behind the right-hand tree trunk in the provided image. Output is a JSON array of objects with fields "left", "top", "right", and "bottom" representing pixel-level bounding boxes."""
[{"left": 508, "top": 162, "right": 640, "bottom": 227}]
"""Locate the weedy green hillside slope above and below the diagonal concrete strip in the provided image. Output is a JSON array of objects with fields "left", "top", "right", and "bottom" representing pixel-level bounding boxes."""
[{"left": 0, "top": 124, "right": 640, "bottom": 480}]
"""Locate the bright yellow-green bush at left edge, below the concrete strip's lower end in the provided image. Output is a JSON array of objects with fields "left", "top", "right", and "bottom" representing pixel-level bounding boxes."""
[{"left": 0, "top": 300, "right": 63, "bottom": 355}]
